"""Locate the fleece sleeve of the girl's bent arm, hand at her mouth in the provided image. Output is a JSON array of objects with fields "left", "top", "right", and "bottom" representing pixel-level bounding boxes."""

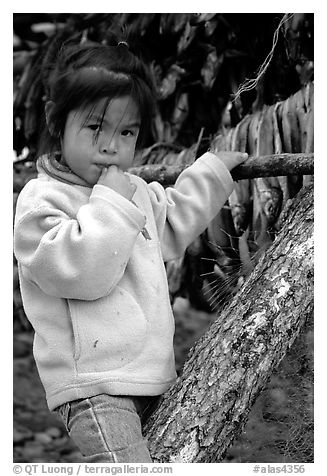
[{"left": 14, "top": 185, "right": 145, "bottom": 300}]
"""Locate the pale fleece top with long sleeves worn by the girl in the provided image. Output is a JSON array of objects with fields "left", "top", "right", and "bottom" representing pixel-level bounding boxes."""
[{"left": 14, "top": 153, "right": 233, "bottom": 410}]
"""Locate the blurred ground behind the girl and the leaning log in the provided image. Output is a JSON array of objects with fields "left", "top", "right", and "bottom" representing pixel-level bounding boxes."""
[{"left": 13, "top": 299, "right": 313, "bottom": 463}]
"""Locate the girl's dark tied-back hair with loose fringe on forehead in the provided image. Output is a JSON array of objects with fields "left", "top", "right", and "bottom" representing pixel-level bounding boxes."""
[{"left": 39, "top": 42, "right": 155, "bottom": 153}]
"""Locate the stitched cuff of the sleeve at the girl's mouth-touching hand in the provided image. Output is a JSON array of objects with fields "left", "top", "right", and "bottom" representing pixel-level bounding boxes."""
[{"left": 90, "top": 184, "right": 146, "bottom": 231}]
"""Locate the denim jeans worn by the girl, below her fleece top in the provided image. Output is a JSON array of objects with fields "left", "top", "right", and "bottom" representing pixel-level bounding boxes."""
[{"left": 56, "top": 394, "right": 157, "bottom": 463}]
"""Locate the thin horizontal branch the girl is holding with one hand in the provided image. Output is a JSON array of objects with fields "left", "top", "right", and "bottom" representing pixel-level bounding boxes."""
[{"left": 129, "top": 154, "right": 314, "bottom": 185}]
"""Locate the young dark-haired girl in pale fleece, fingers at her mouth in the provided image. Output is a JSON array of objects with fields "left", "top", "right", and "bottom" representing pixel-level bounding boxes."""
[{"left": 14, "top": 42, "right": 247, "bottom": 463}]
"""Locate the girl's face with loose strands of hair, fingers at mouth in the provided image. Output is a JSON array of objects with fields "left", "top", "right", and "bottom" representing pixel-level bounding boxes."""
[{"left": 61, "top": 96, "right": 141, "bottom": 186}]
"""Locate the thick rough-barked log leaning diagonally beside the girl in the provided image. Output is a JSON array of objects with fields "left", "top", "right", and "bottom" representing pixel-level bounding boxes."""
[{"left": 145, "top": 184, "right": 313, "bottom": 463}]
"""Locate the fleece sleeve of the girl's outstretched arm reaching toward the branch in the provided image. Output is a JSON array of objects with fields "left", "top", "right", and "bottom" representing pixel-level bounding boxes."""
[{"left": 149, "top": 152, "right": 233, "bottom": 261}]
